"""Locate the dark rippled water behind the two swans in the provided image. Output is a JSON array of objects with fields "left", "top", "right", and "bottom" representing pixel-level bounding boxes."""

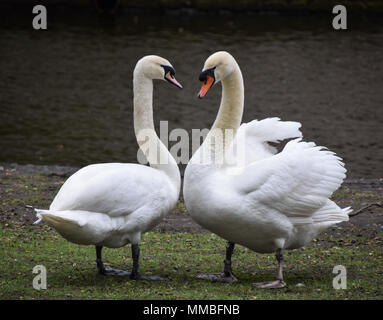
[{"left": 0, "top": 12, "right": 383, "bottom": 178}]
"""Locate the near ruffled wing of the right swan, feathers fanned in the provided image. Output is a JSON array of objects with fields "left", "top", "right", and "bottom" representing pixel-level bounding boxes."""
[{"left": 233, "top": 139, "right": 346, "bottom": 223}]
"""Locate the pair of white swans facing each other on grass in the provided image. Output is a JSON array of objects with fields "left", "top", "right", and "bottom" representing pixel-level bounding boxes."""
[{"left": 36, "top": 52, "right": 350, "bottom": 288}]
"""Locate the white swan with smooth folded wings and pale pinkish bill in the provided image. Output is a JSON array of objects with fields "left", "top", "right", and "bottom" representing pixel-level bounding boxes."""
[{"left": 36, "top": 56, "right": 182, "bottom": 279}]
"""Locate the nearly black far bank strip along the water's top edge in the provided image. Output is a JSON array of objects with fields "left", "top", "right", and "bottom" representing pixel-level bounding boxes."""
[{"left": 0, "top": 0, "right": 383, "bottom": 16}]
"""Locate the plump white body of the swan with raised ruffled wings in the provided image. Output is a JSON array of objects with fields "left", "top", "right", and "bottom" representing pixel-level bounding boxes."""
[{"left": 184, "top": 139, "right": 349, "bottom": 253}]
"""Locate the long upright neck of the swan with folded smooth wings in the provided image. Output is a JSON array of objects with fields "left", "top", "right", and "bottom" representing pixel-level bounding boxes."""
[{"left": 133, "top": 70, "right": 181, "bottom": 192}]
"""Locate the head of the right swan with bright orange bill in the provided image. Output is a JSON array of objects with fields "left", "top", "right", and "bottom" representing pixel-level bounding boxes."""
[{"left": 198, "top": 51, "right": 237, "bottom": 99}]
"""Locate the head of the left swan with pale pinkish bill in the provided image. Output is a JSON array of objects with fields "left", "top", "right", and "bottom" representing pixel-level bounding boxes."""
[{"left": 133, "top": 55, "right": 182, "bottom": 89}]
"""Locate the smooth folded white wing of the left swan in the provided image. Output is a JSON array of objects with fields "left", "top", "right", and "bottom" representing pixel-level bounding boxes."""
[{"left": 50, "top": 163, "right": 167, "bottom": 217}]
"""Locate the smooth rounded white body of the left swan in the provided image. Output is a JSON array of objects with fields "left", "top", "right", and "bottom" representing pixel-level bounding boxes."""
[{"left": 37, "top": 163, "right": 178, "bottom": 248}]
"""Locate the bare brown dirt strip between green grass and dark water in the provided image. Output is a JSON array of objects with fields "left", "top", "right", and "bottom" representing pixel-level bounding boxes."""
[{"left": 0, "top": 164, "right": 383, "bottom": 233}]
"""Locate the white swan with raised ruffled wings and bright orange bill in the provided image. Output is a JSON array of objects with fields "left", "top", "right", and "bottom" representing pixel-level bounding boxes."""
[{"left": 183, "top": 52, "right": 351, "bottom": 288}]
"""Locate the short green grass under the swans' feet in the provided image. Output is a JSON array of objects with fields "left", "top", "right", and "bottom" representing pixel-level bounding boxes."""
[{"left": 0, "top": 222, "right": 383, "bottom": 299}]
